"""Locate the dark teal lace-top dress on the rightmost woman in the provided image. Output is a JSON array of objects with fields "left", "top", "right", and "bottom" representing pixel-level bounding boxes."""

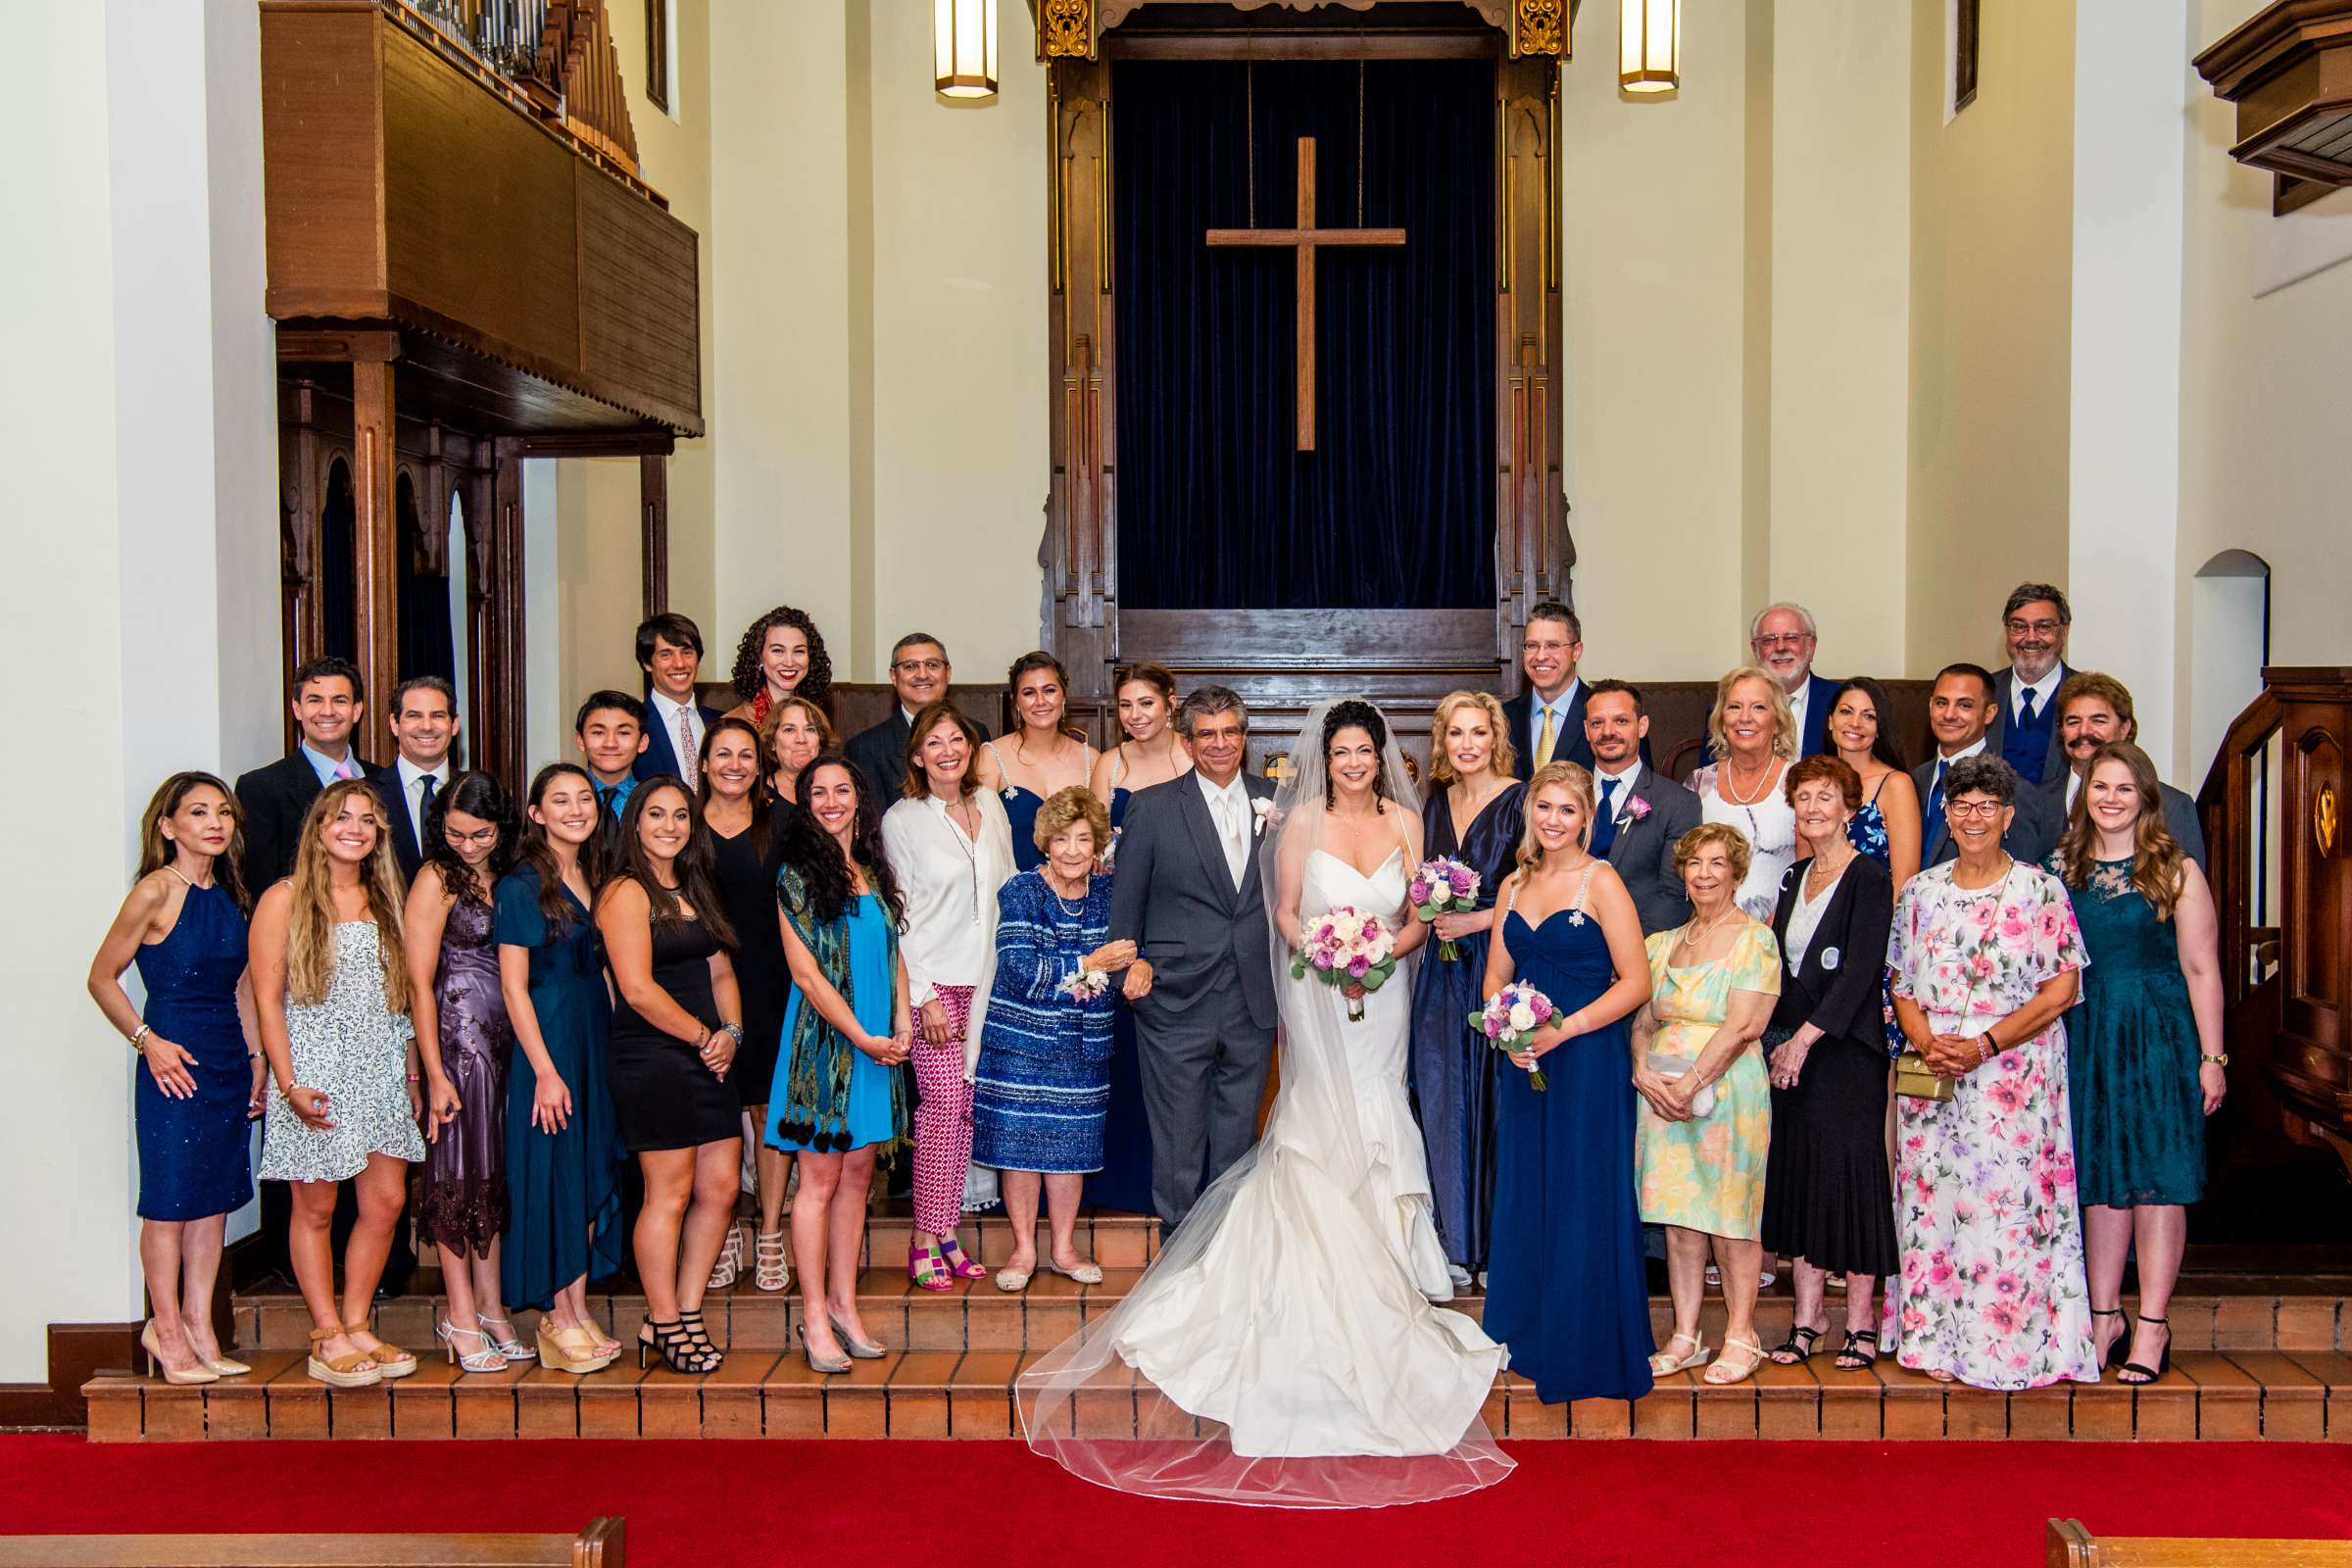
[{"left": 2051, "top": 856, "right": 2204, "bottom": 1208}]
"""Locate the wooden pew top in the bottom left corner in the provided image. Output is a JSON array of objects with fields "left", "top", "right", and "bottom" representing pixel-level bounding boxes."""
[{"left": 0, "top": 1519, "right": 628, "bottom": 1568}]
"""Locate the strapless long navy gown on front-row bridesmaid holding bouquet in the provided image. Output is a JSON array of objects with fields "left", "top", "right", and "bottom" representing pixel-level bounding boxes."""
[{"left": 1484, "top": 909, "right": 1656, "bottom": 1403}]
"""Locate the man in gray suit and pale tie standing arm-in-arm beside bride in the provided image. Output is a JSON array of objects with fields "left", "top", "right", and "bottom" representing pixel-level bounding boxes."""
[{"left": 1110, "top": 686, "right": 1275, "bottom": 1230}]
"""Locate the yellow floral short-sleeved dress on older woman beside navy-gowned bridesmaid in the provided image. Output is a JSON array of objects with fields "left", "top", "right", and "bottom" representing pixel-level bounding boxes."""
[{"left": 1635, "top": 921, "right": 1781, "bottom": 1242}]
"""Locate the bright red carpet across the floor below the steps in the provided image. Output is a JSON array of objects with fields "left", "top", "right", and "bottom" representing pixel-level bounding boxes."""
[{"left": 0, "top": 1437, "right": 2352, "bottom": 1568}]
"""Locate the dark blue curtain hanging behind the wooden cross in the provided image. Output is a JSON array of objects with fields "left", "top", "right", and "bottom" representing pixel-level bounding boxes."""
[{"left": 1110, "top": 61, "right": 1495, "bottom": 609}]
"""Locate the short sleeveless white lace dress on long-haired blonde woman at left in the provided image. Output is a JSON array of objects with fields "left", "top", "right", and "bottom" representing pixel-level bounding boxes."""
[{"left": 261, "top": 919, "right": 425, "bottom": 1183}]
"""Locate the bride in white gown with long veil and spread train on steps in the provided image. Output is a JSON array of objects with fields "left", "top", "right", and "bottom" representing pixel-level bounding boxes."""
[{"left": 1016, "top": 701, "right": 1512, "bottom": 1507}]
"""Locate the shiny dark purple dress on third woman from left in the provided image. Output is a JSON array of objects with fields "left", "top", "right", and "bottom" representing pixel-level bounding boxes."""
[{"left": 416, "top": 898, "right": 515, "bottom": 1255}]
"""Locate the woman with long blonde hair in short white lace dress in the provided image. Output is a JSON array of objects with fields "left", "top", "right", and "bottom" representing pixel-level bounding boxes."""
[{"left": 252, "top": 778, "right": 425, "bottom": 1387}]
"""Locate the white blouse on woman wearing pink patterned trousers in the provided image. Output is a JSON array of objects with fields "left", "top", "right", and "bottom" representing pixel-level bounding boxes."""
[{"left": 882, "top": 790, "right": 1013, "bottom": 1042}]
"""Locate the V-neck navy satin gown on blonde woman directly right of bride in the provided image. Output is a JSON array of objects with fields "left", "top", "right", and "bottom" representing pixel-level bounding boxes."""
[{"left": 1406, "top": 785, "right": 1524, "bottom": 1274}]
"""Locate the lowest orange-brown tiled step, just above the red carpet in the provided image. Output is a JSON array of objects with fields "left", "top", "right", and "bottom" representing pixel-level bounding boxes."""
[{"left": 82, "top": 1349, "right": 2352, "bottom": 1444}]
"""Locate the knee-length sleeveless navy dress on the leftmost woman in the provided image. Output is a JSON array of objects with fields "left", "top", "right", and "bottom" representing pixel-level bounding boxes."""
[{"left": 134, "top": 884, "right": 254, "bottom": 1220}]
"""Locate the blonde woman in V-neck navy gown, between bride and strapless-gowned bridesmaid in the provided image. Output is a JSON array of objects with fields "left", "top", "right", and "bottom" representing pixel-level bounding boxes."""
[{"left": 1406, "top": 691, "right": 1524, "bottom": 1289}]
